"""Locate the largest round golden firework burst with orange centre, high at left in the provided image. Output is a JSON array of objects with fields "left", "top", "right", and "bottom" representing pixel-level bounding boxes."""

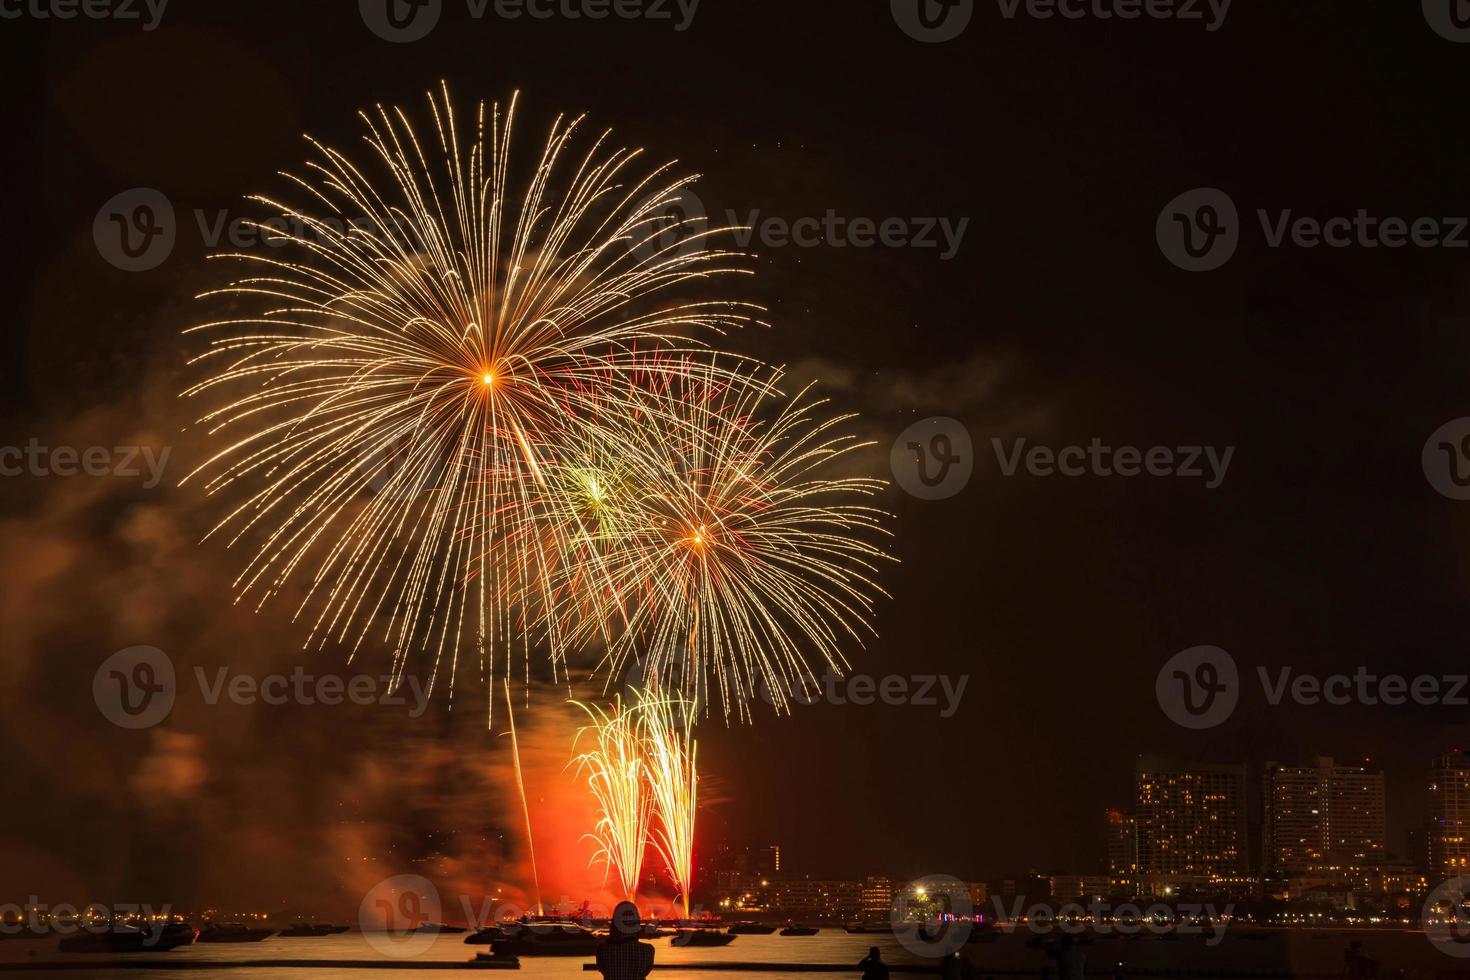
[{"left": 177, "top": 88, "right": 754, "bottom": 711}]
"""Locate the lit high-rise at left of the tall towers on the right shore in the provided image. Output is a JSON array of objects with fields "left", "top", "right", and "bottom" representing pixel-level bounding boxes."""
[{"left": 1133, "top": 755, "right": 1247, "bottom": 880}]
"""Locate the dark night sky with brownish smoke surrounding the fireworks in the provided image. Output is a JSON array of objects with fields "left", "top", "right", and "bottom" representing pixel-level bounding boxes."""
[{"left": 0, "top": 0, "right": 1470, "bottom": 922}]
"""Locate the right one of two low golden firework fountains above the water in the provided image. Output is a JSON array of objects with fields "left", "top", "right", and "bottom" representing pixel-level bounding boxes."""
[{"left": 637, "top": 695, "right": 700, "bottom": 918}]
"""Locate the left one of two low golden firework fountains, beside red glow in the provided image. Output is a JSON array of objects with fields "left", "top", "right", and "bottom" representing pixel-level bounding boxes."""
[{"left": 572, "top": 699, "right": 653, "bottom": 901}]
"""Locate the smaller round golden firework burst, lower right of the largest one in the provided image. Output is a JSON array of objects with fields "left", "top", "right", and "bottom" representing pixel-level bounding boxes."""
[{"left": 547, "top": 360, "right": 891, "bottom": 720}]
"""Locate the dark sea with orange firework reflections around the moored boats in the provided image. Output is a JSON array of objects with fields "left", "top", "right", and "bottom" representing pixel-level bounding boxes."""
[{"left": 0, "top": 929, "right": 1470, "bottom": 980}]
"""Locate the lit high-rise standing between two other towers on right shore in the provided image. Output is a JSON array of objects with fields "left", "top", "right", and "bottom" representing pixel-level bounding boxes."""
[{"left": 1261, "top": 758, "right": 1388, "bottom": 876}]
